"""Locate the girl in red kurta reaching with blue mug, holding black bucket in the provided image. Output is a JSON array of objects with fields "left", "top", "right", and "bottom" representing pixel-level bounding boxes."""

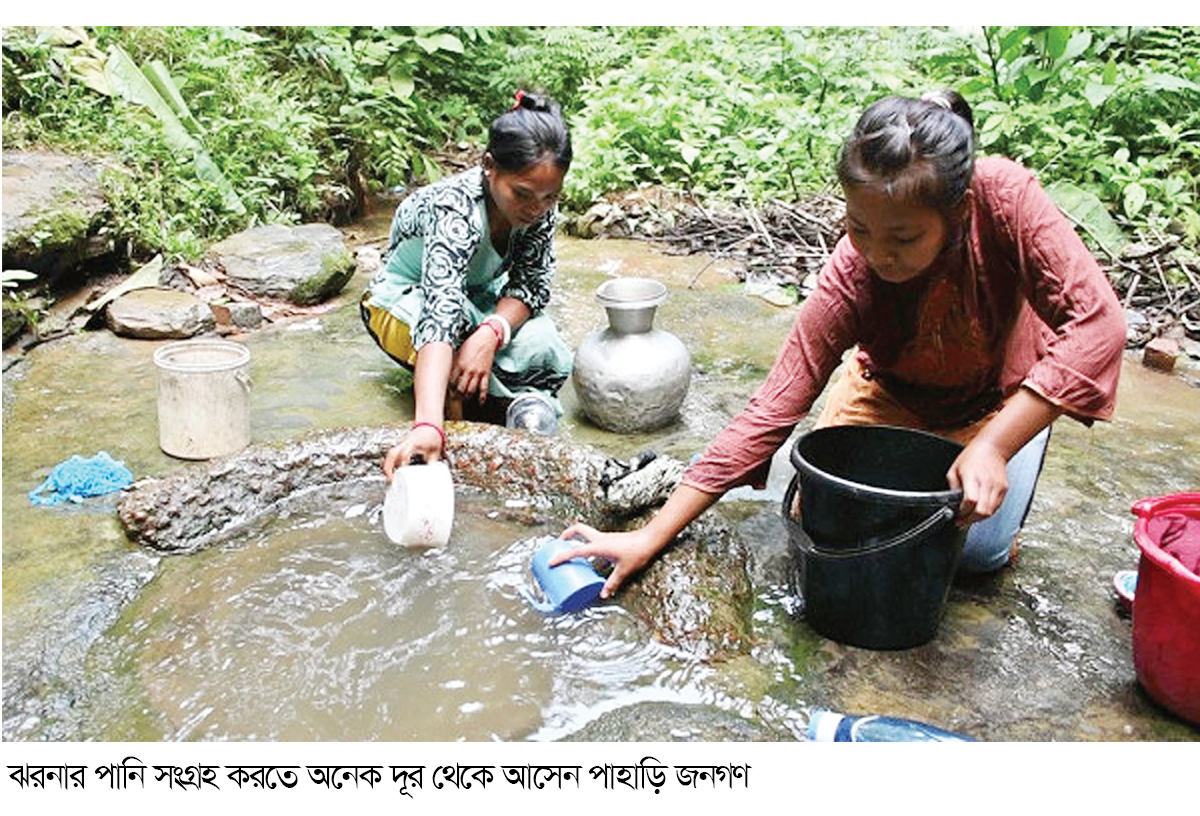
[{"left": 556, "top": 92, "right": 1126, "bottom": 598}]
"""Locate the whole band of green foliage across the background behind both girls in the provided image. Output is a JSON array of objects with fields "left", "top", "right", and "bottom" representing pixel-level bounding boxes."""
[{"left": 4, "top": 26, "right": 1200, "bottom": 261}]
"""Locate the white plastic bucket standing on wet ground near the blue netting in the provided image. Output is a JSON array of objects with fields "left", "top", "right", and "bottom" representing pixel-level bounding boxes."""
[{"left": 154, "top": 340, "right": 250, "bottom": 460}]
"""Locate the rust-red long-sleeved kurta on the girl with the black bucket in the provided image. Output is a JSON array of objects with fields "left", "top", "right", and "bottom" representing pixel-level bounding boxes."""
[{"left": 684, "top": 158, "right": 1126, "bottom": 493}]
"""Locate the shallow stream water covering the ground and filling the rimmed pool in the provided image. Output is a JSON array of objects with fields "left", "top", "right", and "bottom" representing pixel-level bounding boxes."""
[{"left": 4, "top": 226, "right": 1200, "bottom": 740}]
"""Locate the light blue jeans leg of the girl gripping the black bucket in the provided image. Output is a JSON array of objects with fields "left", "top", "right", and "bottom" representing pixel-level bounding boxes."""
[{"left": 959, "top": 426, "right": 1050, "bottom": 572}]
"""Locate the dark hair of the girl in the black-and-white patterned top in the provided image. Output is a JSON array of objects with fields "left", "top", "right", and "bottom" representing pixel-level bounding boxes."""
[{"left": 487, "top": 91, "right": 571, "bottom": 173}]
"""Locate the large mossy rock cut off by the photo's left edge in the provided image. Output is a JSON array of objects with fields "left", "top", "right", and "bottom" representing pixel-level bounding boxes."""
[{"left": 4, "top": 150, "right": 114, "bottom": 282}]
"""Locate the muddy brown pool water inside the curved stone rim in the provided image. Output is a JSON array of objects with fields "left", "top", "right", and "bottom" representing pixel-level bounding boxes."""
[{"left": 68, "top": 484, "right": 720, "bottom": 742}]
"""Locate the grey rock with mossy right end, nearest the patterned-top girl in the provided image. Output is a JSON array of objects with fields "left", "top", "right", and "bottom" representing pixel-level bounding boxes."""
[{"left": 210, "top": 223, "right": 354, "bottom": 305}]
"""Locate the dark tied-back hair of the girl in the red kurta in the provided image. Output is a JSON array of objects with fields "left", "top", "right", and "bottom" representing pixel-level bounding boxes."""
[{"left": 838, "top": 91, "right": 974, "bottom": 211}]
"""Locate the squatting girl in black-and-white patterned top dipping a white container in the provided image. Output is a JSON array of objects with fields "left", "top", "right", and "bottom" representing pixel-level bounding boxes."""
[{"left": 361, "top": 91, "right": 572, "bottom": 479}]
